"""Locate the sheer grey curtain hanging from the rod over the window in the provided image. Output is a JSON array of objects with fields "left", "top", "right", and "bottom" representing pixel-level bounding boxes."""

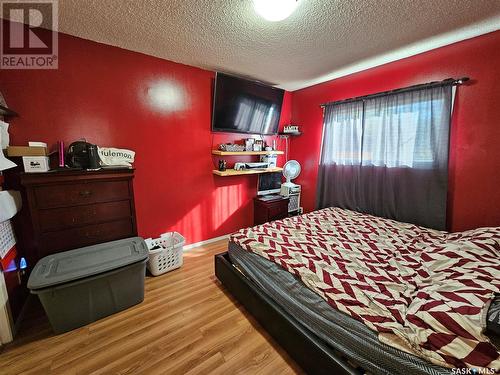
[{"left": 318, "top": 85, "right": 452, "bottom": 229}]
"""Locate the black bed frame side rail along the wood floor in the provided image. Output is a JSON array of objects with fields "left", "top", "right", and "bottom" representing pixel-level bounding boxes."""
[{"left": 215, "top": 252, "right": 363, "bottom": 375}]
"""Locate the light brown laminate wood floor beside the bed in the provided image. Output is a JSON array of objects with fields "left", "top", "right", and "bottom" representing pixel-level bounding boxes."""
[{"left": 0, "top": 241, "right": 302, "bottom": 375}]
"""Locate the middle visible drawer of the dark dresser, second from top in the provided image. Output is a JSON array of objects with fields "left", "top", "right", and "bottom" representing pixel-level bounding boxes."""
[{"left": 38, "top": 200, "right": 132, "bottom": 233}]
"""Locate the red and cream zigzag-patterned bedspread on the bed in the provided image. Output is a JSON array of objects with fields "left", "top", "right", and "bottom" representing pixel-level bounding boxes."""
[{"left": 231, "top": 208, "right": 500, "bottom": 371}]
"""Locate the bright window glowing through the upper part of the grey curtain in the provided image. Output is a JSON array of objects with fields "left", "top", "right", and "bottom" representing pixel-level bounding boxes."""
[{"left": 323, "top": 97, "right": 447, "bottom": 168}]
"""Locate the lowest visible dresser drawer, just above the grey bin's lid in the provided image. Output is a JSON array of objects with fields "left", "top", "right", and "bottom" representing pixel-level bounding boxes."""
[{"left": 39, "top": 218, "right": 137, "bottom": 258}]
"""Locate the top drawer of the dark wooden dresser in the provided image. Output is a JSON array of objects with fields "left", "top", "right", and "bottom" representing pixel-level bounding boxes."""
[{"left": 33, "top": 180, "right": 131, "bottom": 209}]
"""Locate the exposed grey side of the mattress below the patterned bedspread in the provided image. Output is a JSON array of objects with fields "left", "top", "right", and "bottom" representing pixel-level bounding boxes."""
[{"left": 228, "top": 242, "right": 452, "bottom": 375}]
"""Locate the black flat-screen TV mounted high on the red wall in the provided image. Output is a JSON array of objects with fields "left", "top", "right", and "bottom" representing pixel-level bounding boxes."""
[{"left": 212, "top": 73, "right": 285, "bottom": 135}]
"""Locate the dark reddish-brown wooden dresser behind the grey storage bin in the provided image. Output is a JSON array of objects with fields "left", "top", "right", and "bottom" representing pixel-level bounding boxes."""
[{"left": 9, "top": 169, "right": 137, "bottom": 270}]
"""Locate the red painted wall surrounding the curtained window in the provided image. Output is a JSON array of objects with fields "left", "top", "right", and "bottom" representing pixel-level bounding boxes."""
[{"left": 290, "top": 31, "right": 500, "bottom": 231}]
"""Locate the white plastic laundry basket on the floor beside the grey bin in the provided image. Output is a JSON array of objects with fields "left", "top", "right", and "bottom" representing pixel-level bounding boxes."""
[{"left": 145, "top": 232, "right": 186, "bottom": 276}]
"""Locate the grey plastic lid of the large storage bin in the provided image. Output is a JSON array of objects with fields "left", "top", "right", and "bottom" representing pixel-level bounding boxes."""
[{"left": 28, "top": 237, "right": 148, "bottom": 289}]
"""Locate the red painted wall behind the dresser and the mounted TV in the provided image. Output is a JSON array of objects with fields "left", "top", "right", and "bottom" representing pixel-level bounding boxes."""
[{"left": 0, "top": 34, "right": 291, "bottom": 243}]
